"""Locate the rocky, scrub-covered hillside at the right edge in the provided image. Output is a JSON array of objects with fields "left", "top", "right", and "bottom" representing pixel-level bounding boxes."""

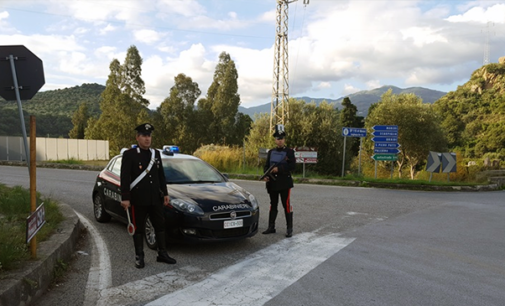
[{"left": 435, "top": 57, "right": 505, "bottom": 159}]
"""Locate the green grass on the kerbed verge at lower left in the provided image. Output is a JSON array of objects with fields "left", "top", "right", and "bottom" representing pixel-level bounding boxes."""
[{"left": 0, "top": 184, "right": 63, "bottom": 274}]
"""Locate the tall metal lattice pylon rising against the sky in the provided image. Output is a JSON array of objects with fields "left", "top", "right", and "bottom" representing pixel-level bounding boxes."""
[{"left": 270, "top": 0, "right": 309, "bottom": 131}]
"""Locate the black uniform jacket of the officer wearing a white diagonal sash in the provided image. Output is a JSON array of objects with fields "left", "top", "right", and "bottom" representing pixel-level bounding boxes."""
[{"left": 121, "top": 148, "right": 168, "bottom": 205}]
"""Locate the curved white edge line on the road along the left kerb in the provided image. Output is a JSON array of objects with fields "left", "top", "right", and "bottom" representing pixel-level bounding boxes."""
[{"left": 75, "top": 212, "right": 112, "bottom": 306}]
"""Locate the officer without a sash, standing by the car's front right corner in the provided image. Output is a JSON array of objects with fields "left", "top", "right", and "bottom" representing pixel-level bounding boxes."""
[{"left": 263, "top": 124, "right": 296, "bottom": 237}]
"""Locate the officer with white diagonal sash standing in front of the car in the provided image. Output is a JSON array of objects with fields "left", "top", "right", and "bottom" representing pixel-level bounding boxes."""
[{"left": 121, "top": 123, "right": 176, "bottom": 269}]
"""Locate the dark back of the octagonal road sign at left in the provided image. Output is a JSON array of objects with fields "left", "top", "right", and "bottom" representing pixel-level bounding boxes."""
[{"left": 0, "top": 46, "right": 45, "bottom": 101}]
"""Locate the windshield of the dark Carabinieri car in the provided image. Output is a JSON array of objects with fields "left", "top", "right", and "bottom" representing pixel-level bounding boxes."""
[{"left": 163, "top": 158, "right": 224, "bottom": 184}]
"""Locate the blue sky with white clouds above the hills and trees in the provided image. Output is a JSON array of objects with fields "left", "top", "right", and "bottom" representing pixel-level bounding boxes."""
[{"left": 0, "top": 0, "right": 505, "bottom": 109}]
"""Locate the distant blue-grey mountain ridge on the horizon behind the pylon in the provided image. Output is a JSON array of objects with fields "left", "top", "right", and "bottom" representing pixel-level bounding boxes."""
[{"left": 239, "top": 86, "right": 446, "bottom": 118}]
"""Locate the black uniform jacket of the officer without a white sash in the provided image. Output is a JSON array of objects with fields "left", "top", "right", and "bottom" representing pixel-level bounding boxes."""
[{"left": 263, "top": 147, "right": 296, "bottom": 190}]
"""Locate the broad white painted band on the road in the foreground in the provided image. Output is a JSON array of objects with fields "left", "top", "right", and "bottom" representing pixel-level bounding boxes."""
[{"left": 144, "top": 233, "right": 354, "bottom": 306}]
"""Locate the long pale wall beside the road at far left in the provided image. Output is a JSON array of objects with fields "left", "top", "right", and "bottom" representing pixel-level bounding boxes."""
[{"left": 0, "top": 136, "right": 109, "bottom": 161}]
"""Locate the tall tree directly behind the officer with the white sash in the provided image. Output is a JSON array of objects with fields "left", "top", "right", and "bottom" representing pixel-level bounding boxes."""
[{"left": 85, "top": 46, "right": 148, "bottom": 154}]
